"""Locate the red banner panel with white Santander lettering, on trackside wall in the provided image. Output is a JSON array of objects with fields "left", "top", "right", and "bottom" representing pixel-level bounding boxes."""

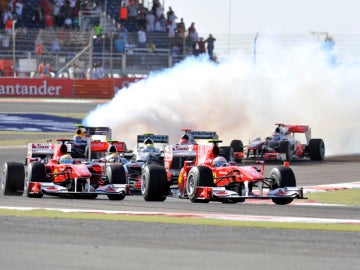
[{"left": 0, "top": 78, "right": 74, "bottom": 98}]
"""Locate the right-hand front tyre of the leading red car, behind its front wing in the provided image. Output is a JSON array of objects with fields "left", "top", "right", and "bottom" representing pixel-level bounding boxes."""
[{"left": 269, "top": 166, "right": 296, "bottom": 205}]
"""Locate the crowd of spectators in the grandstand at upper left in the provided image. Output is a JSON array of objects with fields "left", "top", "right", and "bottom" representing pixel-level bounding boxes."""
[{"left": 0, "top": 0, "right": 216, "bottom": 78}]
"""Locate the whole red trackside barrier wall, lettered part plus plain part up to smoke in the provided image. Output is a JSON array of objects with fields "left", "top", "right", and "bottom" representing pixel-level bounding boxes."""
[{"left": 0, "top": 77, "right": 139, "bottom": 99}]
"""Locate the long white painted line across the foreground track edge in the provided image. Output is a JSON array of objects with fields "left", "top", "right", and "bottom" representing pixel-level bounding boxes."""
[{"left": 0, "top": 206, "right": 360, "bottom": 224}]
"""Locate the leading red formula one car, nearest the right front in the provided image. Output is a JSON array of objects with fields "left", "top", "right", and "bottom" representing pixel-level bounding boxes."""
[{"left": 141, "top": 137, "right": 303, "bottom": 204}]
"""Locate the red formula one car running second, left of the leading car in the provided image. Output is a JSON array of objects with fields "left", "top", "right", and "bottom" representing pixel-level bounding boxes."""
[{"left": 2, "top": 139, "right": 129, "bottom": 200}]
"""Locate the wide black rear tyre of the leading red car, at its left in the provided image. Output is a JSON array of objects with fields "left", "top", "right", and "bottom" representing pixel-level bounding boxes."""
[{"left": 141, "top": 164, "right": 169, "bottom": 201}]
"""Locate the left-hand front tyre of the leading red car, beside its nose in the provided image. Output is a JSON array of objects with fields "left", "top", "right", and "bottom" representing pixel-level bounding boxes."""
[{"left": 186, "top": 166, "right": 215, "bottom": 203}]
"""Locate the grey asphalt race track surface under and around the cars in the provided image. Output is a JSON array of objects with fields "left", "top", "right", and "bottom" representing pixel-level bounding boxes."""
[{"left": 0, "top": 99, "right": 360, "bottom": 269}]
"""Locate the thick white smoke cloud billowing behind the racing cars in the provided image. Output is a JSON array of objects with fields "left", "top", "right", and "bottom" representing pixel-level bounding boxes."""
[{"left": 83, "top": 41, "right": 360, "bottom": 155}]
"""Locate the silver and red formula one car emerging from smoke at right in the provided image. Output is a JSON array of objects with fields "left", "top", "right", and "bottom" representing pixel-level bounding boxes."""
[{"left": 243, "top": 124, "right": 325, "bottom": 161}]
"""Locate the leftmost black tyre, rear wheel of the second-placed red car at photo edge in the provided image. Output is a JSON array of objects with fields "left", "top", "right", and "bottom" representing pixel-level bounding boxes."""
[{"left": 1, "top": 162, "right": 25, "bottom": 196}]
